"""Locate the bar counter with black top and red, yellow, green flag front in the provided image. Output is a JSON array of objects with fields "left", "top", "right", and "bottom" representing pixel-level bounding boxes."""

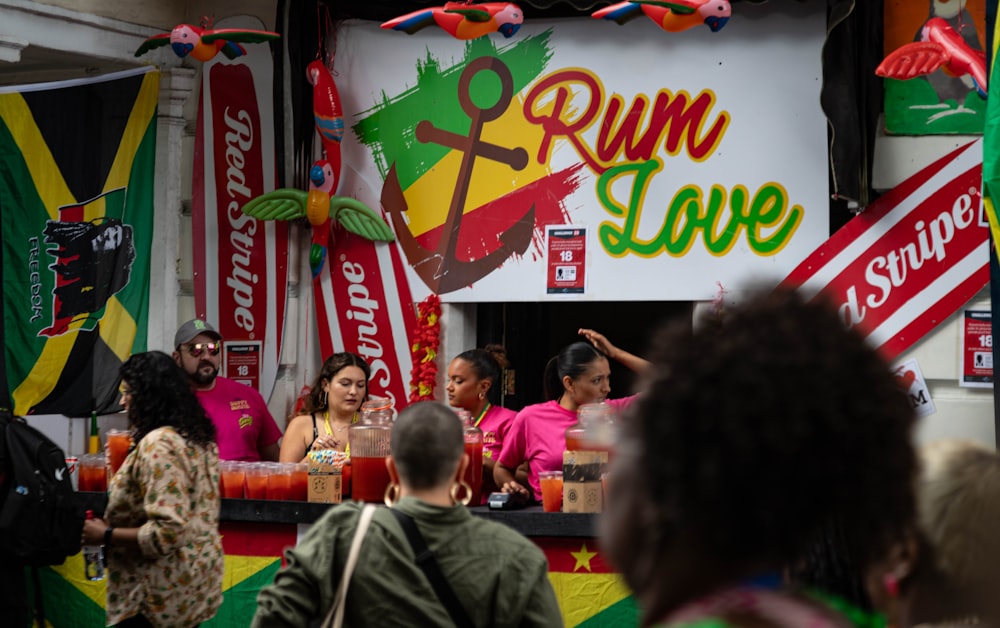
[{"left": 41, "top": 493, "right": 637, "bottom": 628}]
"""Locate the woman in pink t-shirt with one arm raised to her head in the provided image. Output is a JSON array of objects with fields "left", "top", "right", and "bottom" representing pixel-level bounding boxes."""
[{"left": 493, "top": 329, "right": 649, "bottom": 501}]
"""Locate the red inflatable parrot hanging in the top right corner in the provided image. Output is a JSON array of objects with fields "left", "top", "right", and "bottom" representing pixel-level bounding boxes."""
[{"left": 875, "top": 17, "right": 986, "bottom": 98}]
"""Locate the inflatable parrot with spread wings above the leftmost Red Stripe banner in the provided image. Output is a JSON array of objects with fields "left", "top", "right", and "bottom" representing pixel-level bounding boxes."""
[{"left": 135, "top": 17, "right": 281, "bottom": 61}]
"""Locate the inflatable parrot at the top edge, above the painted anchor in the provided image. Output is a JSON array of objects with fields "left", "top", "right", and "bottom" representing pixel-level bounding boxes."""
[{"left": 382, "top": 2, "right": 524, "bottom": 39}]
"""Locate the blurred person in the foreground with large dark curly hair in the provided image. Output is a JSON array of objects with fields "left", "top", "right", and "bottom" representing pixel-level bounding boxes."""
[{"left": 602, "top": 290, "right": 916, "bottom": 628}]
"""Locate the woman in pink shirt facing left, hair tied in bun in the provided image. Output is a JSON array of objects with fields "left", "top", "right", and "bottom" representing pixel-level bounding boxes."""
[{"left": 445, "top": 345, "right": 527, "bottom": 505}]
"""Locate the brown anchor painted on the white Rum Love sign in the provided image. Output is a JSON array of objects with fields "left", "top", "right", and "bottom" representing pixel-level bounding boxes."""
[{"left": 382, "top": 57, "right": 535, "bottom": 294}]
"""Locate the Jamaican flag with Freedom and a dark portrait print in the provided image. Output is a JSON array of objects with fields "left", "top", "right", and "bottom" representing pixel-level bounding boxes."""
[{"left": 0, "top": 69, "right": 159, "bottom": 416}]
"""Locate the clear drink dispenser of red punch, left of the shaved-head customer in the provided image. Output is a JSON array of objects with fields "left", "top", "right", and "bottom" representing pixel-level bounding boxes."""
[{"left": 348, "top": 397, "right": 393, "bottom": 502}]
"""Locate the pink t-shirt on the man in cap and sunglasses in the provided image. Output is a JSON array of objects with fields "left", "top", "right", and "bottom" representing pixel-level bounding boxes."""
[{"left": 195, "top": 377, "right": 281, "bottom": 462}]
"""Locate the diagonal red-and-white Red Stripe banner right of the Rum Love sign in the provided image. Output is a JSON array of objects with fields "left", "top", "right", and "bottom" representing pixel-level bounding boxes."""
[{"left": 782, "top": 140, "right": 989, "bottom": 360}]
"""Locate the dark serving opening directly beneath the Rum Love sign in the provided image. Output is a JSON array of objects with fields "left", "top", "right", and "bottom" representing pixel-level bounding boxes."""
[{"left": 476, "top": 301, "right": 692, "bottom": 410}]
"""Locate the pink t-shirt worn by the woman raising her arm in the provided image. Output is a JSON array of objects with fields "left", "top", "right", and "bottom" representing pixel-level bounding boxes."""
[{"left": 498, "top": 395, "right": 635, "bottom": 501}]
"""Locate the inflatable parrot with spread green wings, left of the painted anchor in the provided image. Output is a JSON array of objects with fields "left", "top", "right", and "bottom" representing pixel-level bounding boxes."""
[{"left": 243, "top": 159, "right": 396, "bottom": 279}]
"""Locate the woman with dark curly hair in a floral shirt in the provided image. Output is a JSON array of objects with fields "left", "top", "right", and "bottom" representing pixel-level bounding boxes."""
[{"left": 81, "top": 351, "right": 223, "bottom": 626}]
